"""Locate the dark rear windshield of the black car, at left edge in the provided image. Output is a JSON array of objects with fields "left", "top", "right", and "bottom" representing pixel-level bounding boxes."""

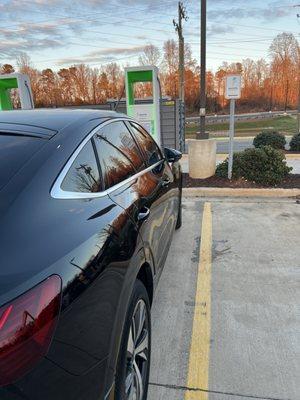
[{"left": 0, "top": 133, "right": 44, "bottom": 189}]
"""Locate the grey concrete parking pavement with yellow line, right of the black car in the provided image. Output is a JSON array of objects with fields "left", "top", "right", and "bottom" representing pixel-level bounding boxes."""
[{"left": 149, "top": 199, "right": 300, "bottom": 400}]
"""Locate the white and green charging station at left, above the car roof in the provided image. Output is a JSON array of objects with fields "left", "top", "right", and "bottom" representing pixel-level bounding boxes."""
[{"left": 0, "top": 73, "right": 34, "bottom": 111}]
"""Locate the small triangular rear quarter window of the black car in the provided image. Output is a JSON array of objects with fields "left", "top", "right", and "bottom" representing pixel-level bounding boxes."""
[{"left": 61, "top": 140, "right": 101, "bottom": 193}]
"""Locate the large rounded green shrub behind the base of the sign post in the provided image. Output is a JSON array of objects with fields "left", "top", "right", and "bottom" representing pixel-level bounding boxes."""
[{"left": 216, "top": 146, "right": 292, "bottom": 186}]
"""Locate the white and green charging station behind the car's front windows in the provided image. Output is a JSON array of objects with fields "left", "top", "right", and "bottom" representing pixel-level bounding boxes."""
[{"left": 125, "top": 65, "right": 162, "bottom": 145}]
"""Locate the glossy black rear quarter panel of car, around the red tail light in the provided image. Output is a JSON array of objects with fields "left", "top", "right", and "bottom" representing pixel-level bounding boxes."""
[{"left": 0, "top": 119, "right": 144, "bottom": 400}]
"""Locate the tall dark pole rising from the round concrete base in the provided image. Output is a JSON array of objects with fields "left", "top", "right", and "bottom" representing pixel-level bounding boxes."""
[{"left": 197, "top": 0, "right": 208, "bottom": 139}]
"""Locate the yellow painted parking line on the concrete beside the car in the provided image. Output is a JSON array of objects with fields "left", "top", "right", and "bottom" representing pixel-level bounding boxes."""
[{"left": 185, "top": 203, "right": 212, "bottom": 400}]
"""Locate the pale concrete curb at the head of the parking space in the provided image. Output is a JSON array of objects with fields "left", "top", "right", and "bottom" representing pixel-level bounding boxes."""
[{"left": 182, "top": 187, "right": 300, "bottom": 198}]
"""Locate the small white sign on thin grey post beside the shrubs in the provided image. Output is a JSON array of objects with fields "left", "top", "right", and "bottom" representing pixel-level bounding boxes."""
[{"left": 225, "top": 75, "right": 242, "bottom": 180}]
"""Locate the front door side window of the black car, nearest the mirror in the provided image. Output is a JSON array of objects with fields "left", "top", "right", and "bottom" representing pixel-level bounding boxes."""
[{"left": 130, "top": 122, "right": 163, "bottom": 166}]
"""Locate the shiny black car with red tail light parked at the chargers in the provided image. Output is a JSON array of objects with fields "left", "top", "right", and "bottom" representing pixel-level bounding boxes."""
[{"left": 0, "top": 110, "right": 182, "bottom": 400}]
